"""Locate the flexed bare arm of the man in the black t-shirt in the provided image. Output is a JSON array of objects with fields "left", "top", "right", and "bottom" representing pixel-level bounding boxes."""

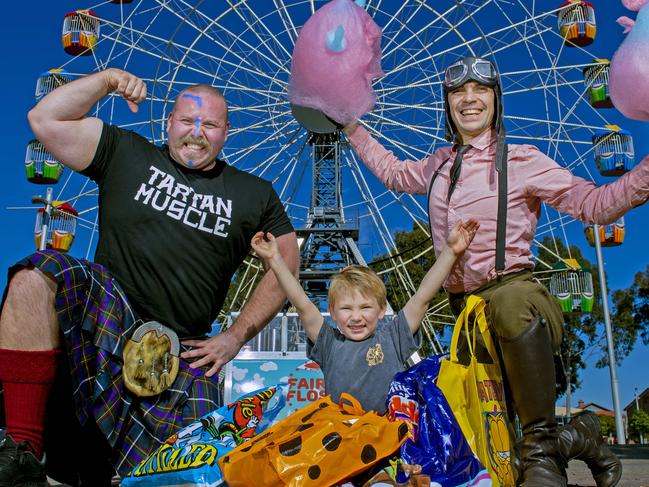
[{"left": 28, "top": 68, "right": 146, "bottom": 171}]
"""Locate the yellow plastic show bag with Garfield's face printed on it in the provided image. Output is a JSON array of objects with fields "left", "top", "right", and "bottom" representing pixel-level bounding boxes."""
[{"left": 437, "top": 295, "right": 515, "bottom": 487}]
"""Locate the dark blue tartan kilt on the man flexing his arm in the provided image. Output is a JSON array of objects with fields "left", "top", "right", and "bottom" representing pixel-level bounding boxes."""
[{"left": 4, "top": 250, "right": 222, "bottom": 477}]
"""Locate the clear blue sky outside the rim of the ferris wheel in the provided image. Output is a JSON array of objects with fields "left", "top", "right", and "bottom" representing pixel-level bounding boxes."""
[{"left": 0, "top": 0, "right": 649, "bottom": 414}]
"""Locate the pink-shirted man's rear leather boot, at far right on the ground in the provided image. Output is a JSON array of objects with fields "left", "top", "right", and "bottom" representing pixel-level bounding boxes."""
[{"left": 559, "top": 411, "right": 622, "bottom": 487}]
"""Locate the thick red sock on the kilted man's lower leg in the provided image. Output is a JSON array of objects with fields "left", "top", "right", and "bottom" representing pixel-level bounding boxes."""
[{"left": 0, "top": 349, "right": 61, "bottom": 460}]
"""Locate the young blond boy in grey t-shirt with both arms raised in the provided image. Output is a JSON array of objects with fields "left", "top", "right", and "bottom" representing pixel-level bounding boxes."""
[{"left": 251, "top": 219, "right": 480, "bottom": 414}]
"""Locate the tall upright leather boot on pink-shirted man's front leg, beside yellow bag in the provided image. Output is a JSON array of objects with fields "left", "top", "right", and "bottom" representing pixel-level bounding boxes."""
[{"left": 499, "top": 317, "right": 567, "bottom": 487}]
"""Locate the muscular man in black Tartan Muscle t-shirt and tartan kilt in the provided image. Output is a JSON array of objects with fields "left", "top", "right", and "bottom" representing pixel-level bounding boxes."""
[{"left": 0, "top": 69, "right": 298, "bottom": 486}]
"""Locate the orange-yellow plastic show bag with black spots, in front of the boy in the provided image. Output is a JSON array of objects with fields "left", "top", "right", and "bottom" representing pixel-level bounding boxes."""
[{"left": 219, "top": 393, "right": 408, "bottom": 487}]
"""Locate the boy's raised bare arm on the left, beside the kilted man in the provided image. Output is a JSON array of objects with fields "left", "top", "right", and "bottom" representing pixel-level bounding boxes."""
[{"left": 250, "top": 232, "right": 323, "bottom": 343}]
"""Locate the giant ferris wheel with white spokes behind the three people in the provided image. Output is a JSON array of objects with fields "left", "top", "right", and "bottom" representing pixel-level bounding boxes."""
[{"left": 22, "top": 0, "right": 632, "bottom": 350}]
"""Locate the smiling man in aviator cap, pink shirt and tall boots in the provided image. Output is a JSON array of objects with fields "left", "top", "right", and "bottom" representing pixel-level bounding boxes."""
[{"left": 345, "top": 57, "right": 649, "bottom": 487}]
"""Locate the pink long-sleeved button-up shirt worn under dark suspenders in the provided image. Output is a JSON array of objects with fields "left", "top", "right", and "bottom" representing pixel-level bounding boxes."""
[{"left": 349, "top": 126, "right": 649, "bottom": 292}]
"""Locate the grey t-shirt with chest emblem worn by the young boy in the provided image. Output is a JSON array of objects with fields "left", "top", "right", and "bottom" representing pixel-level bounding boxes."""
[{"left": 307, "top": 311, "right": 421, "bottom": 414}]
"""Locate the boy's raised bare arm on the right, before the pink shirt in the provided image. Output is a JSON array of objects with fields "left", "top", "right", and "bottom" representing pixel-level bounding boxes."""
[{"left": 403, "top": 218, "right": 480, "bottom": 334}]
